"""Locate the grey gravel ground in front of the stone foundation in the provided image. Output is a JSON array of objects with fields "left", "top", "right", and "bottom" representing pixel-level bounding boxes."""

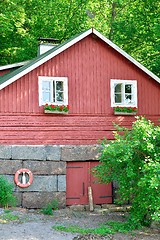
[{"left": 0, "top": 208, "right": 160, "bottom": 240}]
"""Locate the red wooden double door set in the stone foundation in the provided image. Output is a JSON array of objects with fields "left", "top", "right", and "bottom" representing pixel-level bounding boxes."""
[{"left": 66, "top": 162, "right": 112, "bottom": 205}]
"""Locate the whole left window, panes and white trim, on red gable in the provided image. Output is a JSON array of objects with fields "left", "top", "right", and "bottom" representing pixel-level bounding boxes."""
[{"left": 39, "top": 76, "right": 68, "bottom": 106}]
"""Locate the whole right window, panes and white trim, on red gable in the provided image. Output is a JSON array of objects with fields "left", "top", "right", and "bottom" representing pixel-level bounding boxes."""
[{"left": 111, "top": 79, "right": 137, "bottom": 107}]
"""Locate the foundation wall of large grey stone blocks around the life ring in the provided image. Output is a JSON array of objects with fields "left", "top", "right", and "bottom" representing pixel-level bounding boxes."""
[{"left": 0, "top": 145, "right": 99, "bottom": 208}]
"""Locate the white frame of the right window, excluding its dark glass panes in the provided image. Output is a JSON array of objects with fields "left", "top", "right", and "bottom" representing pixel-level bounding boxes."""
[{"left": 110, "top": 79, "right": 137, "bottom": 107}]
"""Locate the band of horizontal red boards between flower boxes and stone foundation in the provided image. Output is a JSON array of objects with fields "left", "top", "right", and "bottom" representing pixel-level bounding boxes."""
[{"left": 0, "top": 115, "right": 158, "bottom": 145}]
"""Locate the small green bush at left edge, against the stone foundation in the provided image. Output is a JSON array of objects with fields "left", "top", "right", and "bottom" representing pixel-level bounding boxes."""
[{"left": 0, "top": 176, "right": 16, "bottom": 207}]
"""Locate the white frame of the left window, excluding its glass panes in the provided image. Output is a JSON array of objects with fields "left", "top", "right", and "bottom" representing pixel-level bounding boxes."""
[{"left": 38, "top": 76, "right": 68, "bottom": 106}]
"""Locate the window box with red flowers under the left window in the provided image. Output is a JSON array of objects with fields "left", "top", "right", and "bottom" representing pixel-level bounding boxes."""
[{"left": 44, "top": 103, "right": 69, "bottom": 114}]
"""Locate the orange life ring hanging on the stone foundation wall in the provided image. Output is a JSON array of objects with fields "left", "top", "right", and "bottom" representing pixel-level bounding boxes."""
[{"left": 14, "top": 168, "right": 33, "bottom": 188}]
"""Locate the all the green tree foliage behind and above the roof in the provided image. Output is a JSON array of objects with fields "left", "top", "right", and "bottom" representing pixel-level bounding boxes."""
[{"left": 0, "top": 0, "right": 160, "bottom": 75}]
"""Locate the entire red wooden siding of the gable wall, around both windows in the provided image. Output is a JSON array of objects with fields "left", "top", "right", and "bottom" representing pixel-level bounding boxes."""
[{"left": 0, "top": 36, "right": 160, "bottom": 144}]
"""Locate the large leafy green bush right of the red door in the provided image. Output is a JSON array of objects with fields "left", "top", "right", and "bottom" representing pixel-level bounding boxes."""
[{"left": 93, "top": 117, "right": 160, "bottom": 227}]
